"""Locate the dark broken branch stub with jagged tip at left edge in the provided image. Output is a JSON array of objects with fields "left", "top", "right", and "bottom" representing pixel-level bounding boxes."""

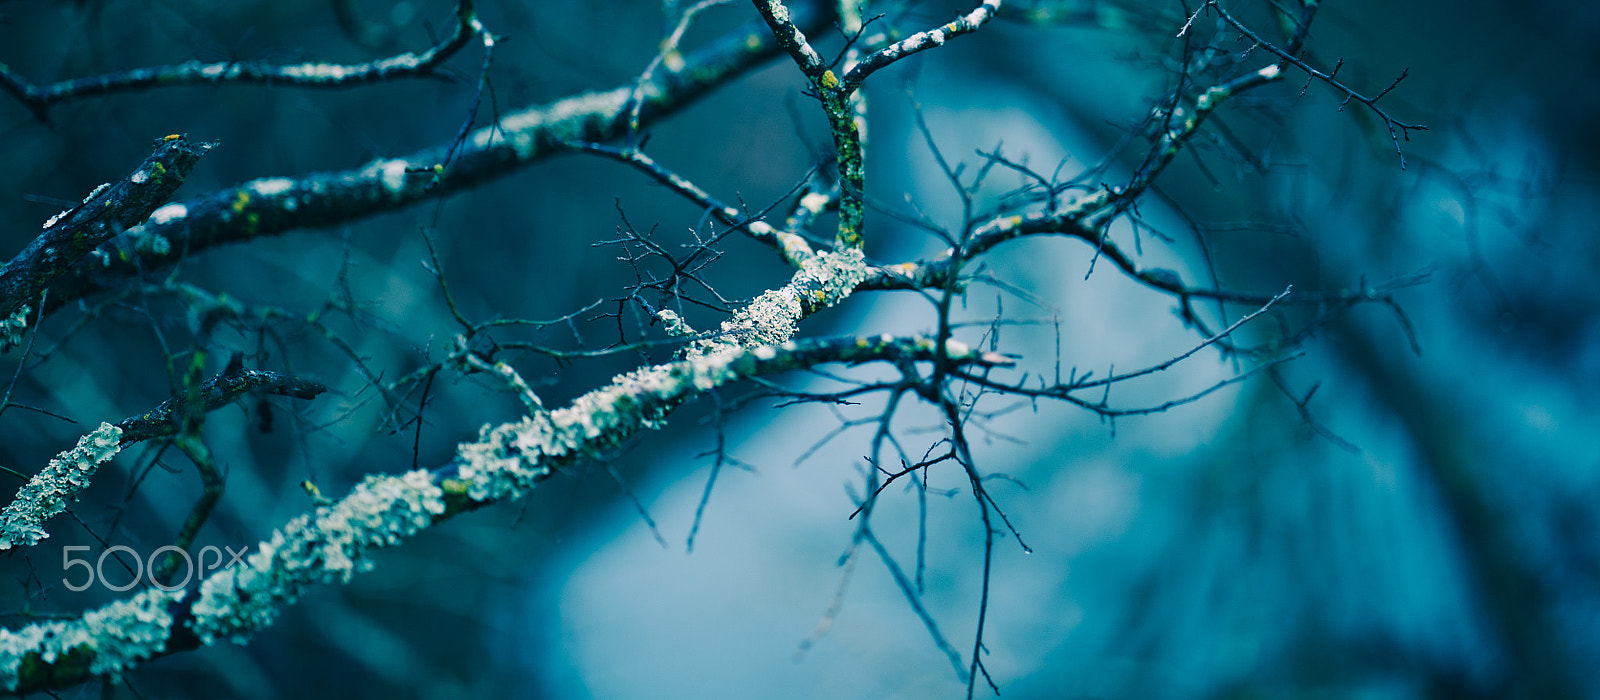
[{"left": 0, "top": 136, "right": 216, "bottom": 318}]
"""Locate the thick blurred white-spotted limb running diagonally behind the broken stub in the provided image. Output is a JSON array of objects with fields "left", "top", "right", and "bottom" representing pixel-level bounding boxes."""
[{"left": 45, "top": 5, "right": 826, "bottom": 321}]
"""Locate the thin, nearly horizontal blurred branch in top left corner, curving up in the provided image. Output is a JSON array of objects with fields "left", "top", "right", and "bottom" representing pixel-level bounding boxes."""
[{"left": 0, "top": 0, "right": 483, "bottom": 120}]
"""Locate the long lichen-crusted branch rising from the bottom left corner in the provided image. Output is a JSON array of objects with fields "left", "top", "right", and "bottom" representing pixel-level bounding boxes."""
[{"left": 0, "top": 336, "right": 1010, "bottom": 694}]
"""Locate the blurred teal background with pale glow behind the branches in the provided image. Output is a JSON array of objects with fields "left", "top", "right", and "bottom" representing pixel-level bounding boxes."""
[{"left": 0, "top": 0, "right": 1600, "bottom": 698}]
